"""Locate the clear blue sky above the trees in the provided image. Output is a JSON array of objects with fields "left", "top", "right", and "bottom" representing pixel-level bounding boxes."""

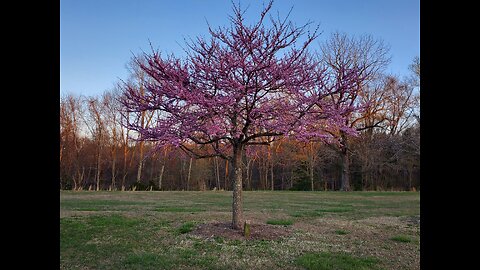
[{"left": 60, "top": 0, "right": 420, "bottom": 95}]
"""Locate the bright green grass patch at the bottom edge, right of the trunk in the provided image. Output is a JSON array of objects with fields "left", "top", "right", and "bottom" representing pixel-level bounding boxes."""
[{"left": 295, "top": 252, "right": 379, "bottom": 270}]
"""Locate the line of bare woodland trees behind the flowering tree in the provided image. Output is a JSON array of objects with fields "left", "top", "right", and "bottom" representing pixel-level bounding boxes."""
[{"left": 60, "top": 55, "right": 420, "bottom": 190}]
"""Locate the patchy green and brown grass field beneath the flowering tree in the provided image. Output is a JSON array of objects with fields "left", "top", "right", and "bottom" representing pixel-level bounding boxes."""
[{"left": 60, "top": 191, "right": 420, "bottom": 269}]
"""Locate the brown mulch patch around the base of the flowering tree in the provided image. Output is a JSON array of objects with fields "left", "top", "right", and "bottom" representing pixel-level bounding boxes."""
[{"left": 190, "top": 222, "right": 292, "bottom": 240}]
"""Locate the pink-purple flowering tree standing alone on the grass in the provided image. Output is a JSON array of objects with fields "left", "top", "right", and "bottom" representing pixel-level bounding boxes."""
[{"left": 122, "top": 2, "right": 362, "bottom": 229}]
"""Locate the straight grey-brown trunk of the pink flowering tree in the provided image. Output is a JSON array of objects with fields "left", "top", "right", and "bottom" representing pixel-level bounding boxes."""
[{"left": 232, "top": 145, "right": 244, "bottom": 230}]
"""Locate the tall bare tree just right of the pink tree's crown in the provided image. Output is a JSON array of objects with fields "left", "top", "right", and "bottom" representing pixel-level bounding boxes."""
[{"left": 321, "top": 32, "right": 390, "bottom": 191}]
